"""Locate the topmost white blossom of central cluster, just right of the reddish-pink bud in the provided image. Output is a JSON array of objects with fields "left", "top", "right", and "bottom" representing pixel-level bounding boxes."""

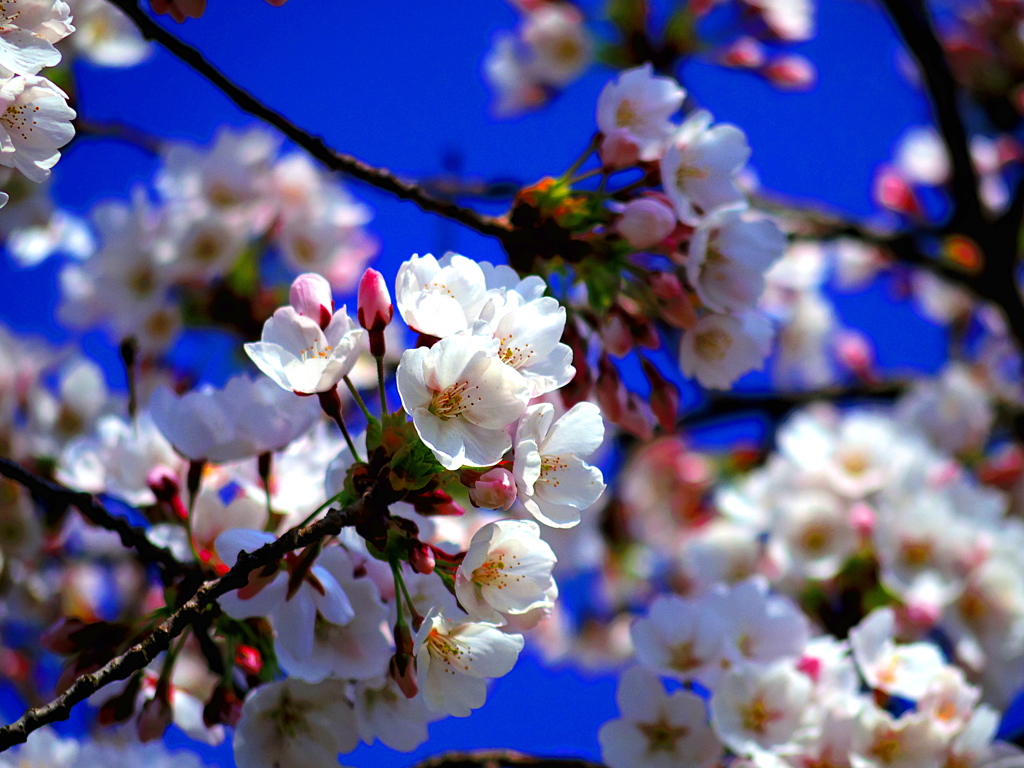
[{"left": 394, "top": 253, "right": 487, "bottom": 339}]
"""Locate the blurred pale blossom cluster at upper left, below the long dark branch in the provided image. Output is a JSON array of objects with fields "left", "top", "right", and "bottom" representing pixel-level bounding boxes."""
[{"left": 58, "top": 130, "right": 376, "bottom": 354}]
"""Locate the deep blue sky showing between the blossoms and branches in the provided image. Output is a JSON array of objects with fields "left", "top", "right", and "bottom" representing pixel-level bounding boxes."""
[{"left": 0, "top": 0, "right": 966, "bottom": 768}]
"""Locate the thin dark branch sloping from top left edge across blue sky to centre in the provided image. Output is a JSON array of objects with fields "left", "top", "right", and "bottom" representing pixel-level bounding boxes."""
[{"left": 101, "top": 0, "right": 510, "bottom": 239}]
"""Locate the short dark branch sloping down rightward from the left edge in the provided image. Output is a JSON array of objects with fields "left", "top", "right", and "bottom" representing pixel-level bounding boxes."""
[{"left": 0, "top": 457, "right": 186, "bottom": 575}]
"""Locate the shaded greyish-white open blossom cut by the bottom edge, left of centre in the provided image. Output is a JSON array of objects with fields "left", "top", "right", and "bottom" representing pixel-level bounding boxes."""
[{"left": 234, "top": 678, "right": 359, "bottom": 768}]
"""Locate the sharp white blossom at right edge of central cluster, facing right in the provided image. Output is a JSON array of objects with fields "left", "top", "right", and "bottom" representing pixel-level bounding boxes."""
[{"left": 512, "top": 402, "right": 605, "bottom": 528}]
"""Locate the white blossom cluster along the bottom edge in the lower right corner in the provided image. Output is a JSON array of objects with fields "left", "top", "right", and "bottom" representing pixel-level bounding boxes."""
[{"left": 599, "top": 580, "right": 1021, "bottom": 768}]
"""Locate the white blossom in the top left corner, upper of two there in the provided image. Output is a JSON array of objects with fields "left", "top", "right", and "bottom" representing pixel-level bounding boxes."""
[{"left": 0, "top": 0, "right": 75, "bottom": 75}]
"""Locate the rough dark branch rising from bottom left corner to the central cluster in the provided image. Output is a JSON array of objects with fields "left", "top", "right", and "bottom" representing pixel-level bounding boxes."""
[{"left": 0, "top": 500, "right": 365, "bottom": 752}]
